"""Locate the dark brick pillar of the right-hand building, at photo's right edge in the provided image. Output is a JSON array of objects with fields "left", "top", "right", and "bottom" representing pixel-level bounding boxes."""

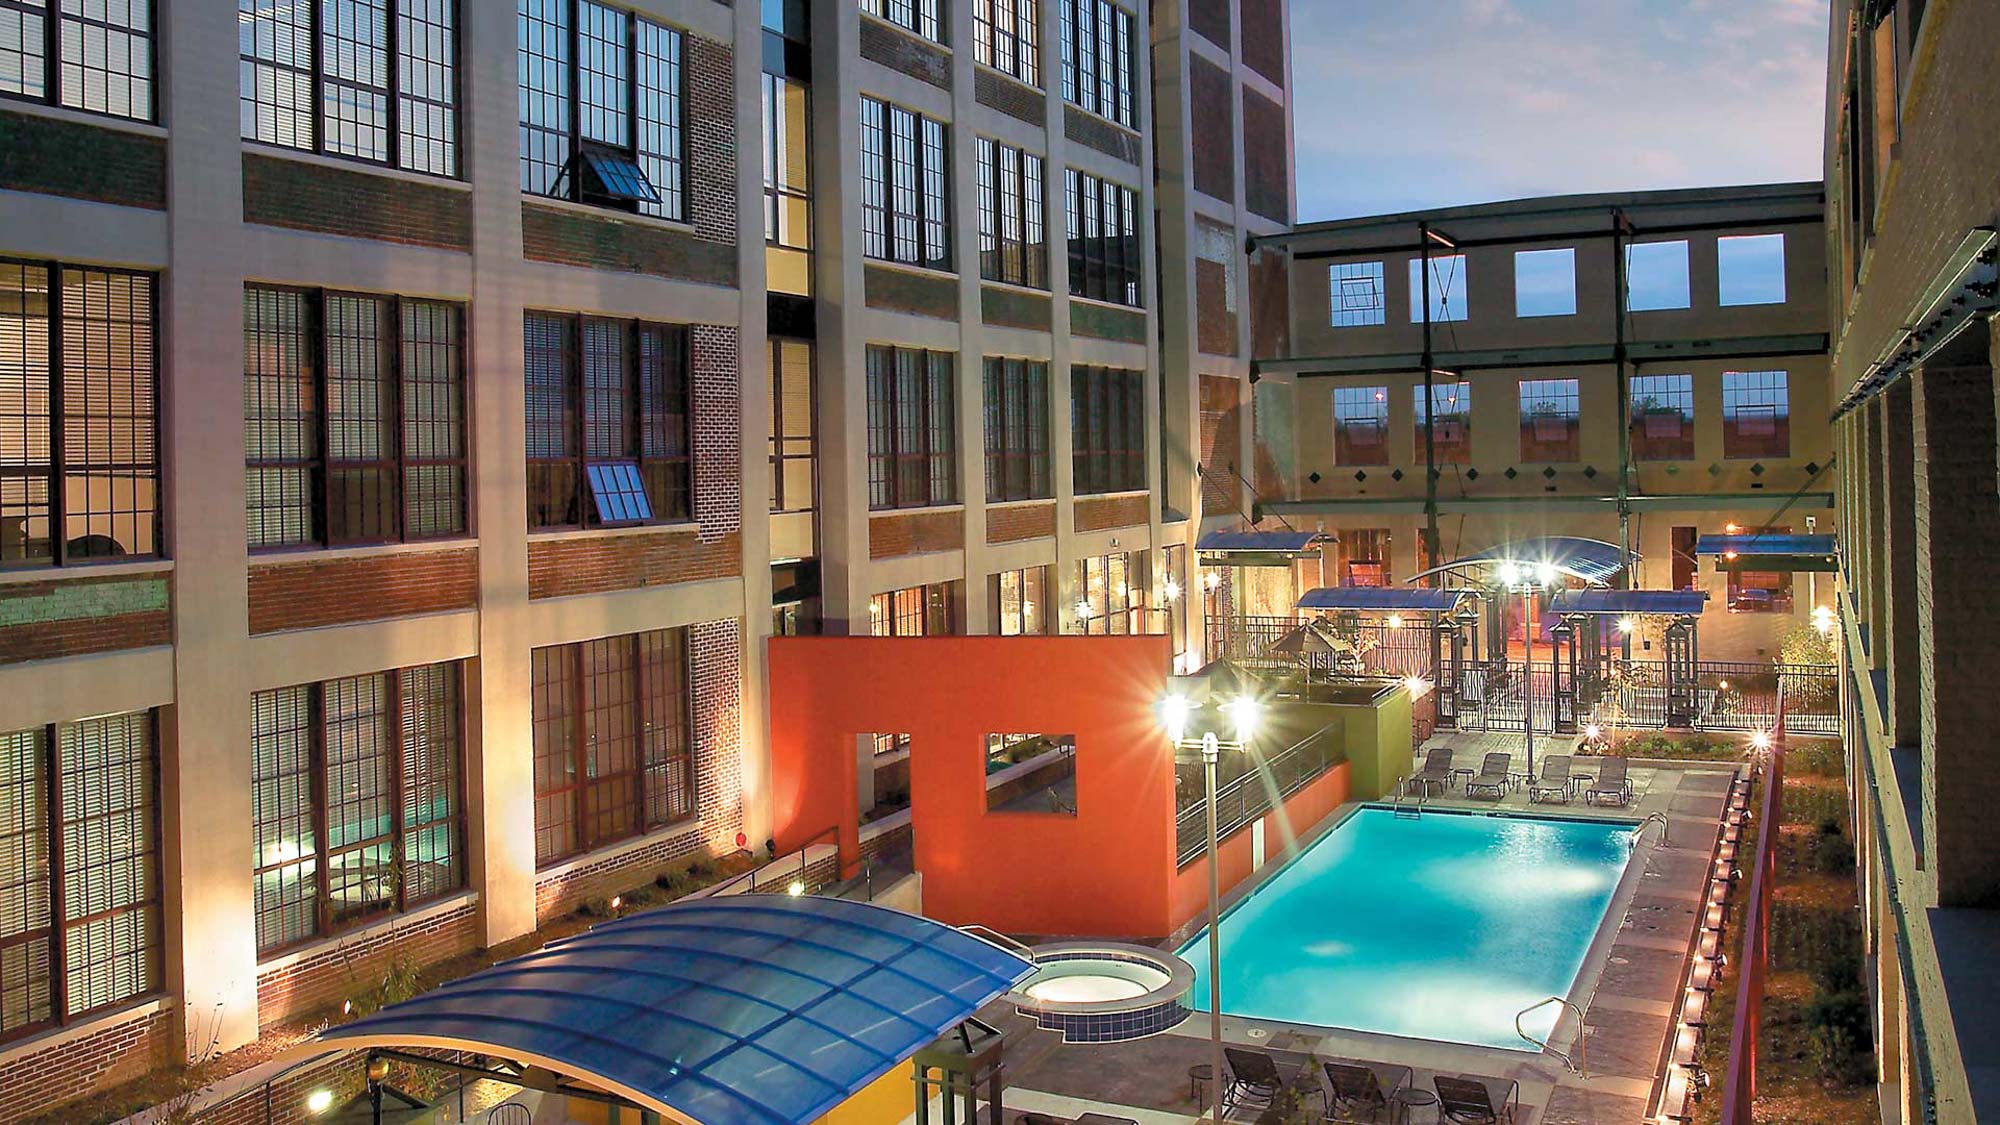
[{"left": 1912, "top": 352, "right": 2000, "bottom": 907}]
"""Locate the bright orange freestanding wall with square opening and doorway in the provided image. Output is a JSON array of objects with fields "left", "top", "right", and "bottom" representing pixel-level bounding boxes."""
[{"left": 770, "top": 637, "right": 1174, "bottom": 937}]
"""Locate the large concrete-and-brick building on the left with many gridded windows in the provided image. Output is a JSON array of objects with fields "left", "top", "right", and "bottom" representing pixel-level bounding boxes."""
[{"left": 0, "top": 0, "right": 1292, "bottom": 1119}]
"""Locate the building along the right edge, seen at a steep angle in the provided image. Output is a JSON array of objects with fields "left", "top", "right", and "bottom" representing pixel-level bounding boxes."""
[{"left": 1826, "top": 0, "right": 2000, "bottom": 1123}]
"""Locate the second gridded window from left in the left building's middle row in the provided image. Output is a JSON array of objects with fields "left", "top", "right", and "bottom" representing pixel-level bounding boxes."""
[{"left": 244, "top": 286, "right": 466, "bottom": 548}]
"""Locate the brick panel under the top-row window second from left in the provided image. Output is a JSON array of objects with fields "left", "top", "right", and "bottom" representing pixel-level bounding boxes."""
[{"left": 244, "top": 152, "right": 472, "bottom": 250}]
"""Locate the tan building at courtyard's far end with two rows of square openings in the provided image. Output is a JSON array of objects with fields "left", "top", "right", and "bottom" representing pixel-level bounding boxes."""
[{"left": 1224, "top": 182, "right": 1834, "bottom": 659}]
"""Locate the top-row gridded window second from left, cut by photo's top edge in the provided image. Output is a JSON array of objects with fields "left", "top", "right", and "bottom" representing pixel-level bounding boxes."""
[{"left": 243, "top": 0, "right": 460, "bottom": 176}]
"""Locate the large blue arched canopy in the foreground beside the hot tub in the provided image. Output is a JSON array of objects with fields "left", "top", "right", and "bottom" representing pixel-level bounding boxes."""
[{"left": 308, "top": 895, "right": 1032, "bottom": 1125}]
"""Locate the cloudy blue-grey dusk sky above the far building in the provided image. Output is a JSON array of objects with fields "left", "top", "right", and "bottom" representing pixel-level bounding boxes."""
[{"left": 1292, "top": 0, "right": 1828, "bottom": 222}]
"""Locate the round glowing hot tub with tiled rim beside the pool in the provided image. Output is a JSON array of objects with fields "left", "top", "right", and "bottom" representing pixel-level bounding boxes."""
[{"left": 1006, "top": 941, "right": 1194, "bottom": 1043}]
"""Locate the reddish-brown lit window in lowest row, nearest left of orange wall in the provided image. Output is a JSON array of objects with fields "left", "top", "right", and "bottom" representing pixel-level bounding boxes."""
[{"left": 532, "top": 629, "right": 694, "bottom": 867}]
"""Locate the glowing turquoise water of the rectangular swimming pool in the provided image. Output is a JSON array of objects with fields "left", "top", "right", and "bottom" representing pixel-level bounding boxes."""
[{"left": 1180, "top": 807, "right": 1632, "bottom": 1051}]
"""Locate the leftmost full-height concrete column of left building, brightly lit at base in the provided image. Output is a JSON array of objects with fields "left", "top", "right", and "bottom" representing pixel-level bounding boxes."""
[{"left": 160, "top": 4, "right": 258, "bottom": 1055}]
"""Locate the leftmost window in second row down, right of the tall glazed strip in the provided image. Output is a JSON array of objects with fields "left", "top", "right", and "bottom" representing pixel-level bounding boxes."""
[{"left": 862, "top": 94, "right": 952, "bottom": 270}]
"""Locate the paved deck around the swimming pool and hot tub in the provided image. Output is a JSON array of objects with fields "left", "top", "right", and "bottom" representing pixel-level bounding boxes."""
[{"left": 936, "top": 733, "right": 1732, "bottom": 1125}]
